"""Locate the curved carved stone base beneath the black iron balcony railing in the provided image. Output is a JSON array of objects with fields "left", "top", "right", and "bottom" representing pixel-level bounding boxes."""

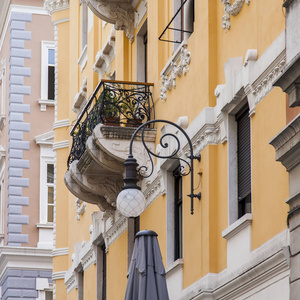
[{"left": 64, "top": 124, "right": 156, "bottom": 212}]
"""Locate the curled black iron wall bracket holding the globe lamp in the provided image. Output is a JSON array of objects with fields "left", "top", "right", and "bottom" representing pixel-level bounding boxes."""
[{"left": 128, "top": 120, "right": 201, "bottom": 214}]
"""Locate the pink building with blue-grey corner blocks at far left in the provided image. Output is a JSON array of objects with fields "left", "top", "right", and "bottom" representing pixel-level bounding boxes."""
[{"left": 0, "top": 0, "right": 55, "bottom": 300}]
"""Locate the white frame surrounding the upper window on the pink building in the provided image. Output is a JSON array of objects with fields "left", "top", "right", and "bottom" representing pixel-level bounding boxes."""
[{"left": 38, "top": 41, "right": 55, "bottom": 111}]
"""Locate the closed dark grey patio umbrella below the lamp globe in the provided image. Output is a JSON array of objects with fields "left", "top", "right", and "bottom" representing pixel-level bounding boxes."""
[{"left": 125, "top": 230, "right": 169, "bottom": 300}]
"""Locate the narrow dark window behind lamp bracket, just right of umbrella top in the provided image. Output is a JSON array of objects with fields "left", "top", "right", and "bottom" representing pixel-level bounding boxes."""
[{"left": 173, "top": 166, "right": 183, "bottom": 260}]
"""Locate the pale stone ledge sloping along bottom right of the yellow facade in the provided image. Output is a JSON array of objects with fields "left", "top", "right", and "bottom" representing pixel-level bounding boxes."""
[{"left": 178, "top": 230, "right": 289, "bottom": 300}]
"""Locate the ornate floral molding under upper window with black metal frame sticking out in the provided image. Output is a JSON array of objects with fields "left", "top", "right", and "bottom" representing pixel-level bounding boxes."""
[{"left": 160, "top": 41, "right": 191, "bottom": 102}]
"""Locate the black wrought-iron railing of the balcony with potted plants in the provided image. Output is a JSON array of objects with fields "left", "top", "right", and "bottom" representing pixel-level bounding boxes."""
[{"left": 67, "top": 80, "right": 155, "bottom": 168}]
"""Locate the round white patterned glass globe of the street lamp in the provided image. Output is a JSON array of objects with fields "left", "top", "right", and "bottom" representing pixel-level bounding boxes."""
[{"left": 117, "top": 188, "right": 146, "bottom": 218}]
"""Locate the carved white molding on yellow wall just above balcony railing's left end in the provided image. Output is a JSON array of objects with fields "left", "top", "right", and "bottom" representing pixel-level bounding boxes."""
[{"left": 93, "top": 28, "right": 116, "bottom": 79}]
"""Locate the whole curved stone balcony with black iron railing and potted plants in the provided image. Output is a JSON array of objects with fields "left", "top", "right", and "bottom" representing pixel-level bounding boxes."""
[{"left": 65, "top": 80, "right": 156, "bottom": 213}]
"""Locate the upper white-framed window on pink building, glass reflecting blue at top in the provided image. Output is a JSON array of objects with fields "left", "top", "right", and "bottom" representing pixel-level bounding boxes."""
[{"left": 39, "top": 41, "right": 55, "bottom": 111}]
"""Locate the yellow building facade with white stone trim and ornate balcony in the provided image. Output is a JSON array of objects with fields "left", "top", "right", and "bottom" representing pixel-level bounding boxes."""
[{"left": 45, "top": 0, "right": 300, "bottom": 300}]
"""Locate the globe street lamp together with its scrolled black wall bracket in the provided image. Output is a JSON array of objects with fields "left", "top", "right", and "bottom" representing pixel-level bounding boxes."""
[{"left": 117, "top": 120, "right": 201, "bottom": 217}]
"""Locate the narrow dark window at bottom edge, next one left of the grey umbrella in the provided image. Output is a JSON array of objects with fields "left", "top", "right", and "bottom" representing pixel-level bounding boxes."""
[{"left": 97, "top": 244, "right": 107, "bottom": 300}]
